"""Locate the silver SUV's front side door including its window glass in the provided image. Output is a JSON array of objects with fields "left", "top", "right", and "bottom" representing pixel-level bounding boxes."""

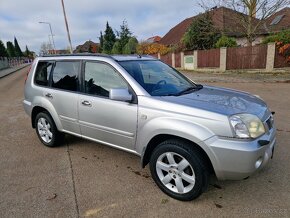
[{"left": 78, "top": 61, "right": 137, "bottom": 150}]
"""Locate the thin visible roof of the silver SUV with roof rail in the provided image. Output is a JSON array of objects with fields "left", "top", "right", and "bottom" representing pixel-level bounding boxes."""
[{"left": 39, "top": 53, "right": 156, "bottom": 61}]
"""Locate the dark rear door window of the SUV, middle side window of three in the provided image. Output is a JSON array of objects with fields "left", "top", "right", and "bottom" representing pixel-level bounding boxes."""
[{"left": 51, "top": 61, "right": 80, "bottom": 91}]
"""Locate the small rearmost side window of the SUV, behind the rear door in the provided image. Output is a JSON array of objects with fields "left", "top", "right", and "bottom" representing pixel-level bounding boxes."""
[{"left": 34, "top": 61, "right": 53, "bottom": 86}]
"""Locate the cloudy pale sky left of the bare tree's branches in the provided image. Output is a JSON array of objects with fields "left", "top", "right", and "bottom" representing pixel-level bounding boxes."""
[{"left": 0, "top": 0, "right": 202, "bottom": 53}]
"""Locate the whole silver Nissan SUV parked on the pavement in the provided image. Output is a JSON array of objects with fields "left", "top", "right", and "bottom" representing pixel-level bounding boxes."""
[{"left": 23, "top": 55, "right": 276, "bottom": 201}]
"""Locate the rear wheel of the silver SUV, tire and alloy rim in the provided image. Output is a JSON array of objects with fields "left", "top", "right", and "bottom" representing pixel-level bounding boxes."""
[{"left": 34, "top": 112, "right": 64, "bottom": 147}]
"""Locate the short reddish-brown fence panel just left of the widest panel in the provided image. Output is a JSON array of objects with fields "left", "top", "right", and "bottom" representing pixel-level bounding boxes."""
[{"left": 197, "top": 49, "right": 220, "bottom": 68}]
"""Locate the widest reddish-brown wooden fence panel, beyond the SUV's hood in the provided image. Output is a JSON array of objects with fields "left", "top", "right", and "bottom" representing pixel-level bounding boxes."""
[{"left": 226, "top": 45, "right": 267, "bottom": 70}]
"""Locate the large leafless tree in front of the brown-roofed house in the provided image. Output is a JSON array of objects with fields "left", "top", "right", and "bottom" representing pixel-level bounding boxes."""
[{"left": 199, "top": 0, "right": 290, "bottom": 46}]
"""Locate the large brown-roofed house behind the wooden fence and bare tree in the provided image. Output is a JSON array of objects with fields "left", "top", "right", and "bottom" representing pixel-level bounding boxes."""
[{"left": 160, "top": 7, "right": 290, "bottom": 46}]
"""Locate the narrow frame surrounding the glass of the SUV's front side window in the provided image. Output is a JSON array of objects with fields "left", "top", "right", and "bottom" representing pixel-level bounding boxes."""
[{"left": 80, "top": 60, "right": 138, "bottom": 104}]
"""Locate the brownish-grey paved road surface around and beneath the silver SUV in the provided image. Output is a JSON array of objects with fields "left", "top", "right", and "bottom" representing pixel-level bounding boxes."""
[{"left": 0, "top": 68, "right": 290, "bottom": 218}]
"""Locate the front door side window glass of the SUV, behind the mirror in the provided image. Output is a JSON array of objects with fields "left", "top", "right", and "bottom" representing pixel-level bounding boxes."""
[{"left": 85, "top": 62, "right": 128, "bottom": 97}]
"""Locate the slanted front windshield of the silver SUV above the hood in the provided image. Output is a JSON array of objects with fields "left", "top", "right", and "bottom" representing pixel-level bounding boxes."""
[{"left": 119, "top": 60, "right": 198, "bottom": 96}]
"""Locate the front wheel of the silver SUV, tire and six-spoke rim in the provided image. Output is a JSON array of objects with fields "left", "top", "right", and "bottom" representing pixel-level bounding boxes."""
[{"left": 150, "top": 140, "right": 209, "bottom": 201}]
